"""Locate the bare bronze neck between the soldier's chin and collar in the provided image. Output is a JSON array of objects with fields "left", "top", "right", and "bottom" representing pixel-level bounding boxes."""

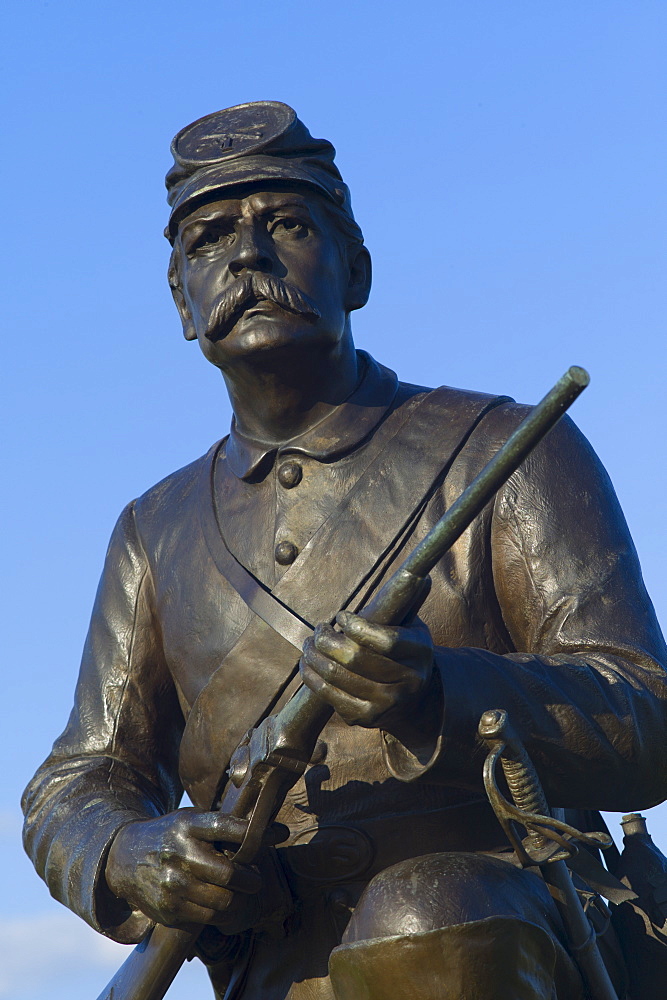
[{"left": 222, "top": 336, "right": 360, "bottom": 444}]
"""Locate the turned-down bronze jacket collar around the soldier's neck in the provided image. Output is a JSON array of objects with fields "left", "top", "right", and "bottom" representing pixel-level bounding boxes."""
[{"left": 226, "top": 351, "right": 398, "bottom": 479}]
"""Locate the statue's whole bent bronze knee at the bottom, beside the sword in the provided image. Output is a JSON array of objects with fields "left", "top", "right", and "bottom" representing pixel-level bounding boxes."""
[{"left": 329, "top": 854, "right": 585, "bottom": 1000}]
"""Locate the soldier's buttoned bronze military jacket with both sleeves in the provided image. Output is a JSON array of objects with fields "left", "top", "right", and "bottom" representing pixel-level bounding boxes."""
[{"left": 24, "top": 355, "right": 667, "bottom": 941}]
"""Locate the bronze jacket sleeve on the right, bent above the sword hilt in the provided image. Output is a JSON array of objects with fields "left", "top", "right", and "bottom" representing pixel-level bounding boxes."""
[{"left": 385, "top": 404, "right": 667, "bottom": 811}]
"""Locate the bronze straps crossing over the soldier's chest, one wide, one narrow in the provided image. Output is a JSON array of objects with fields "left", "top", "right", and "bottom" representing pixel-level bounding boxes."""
[{"left": 180, "top": 386, "right": 508, "bottom": 808}]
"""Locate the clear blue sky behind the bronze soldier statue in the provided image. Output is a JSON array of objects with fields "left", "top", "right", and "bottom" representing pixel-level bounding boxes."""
[{"left": 0, "top": 0, "right": 667, "bottom": 1000}]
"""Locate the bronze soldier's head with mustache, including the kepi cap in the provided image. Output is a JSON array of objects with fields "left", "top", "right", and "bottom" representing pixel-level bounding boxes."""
[{"left": 165, "top": 101, "right": 370, "bottom": 370}]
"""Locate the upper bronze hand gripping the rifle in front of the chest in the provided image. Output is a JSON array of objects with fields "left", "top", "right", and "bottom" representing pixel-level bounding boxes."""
[{"left": 300, "top": 611, "right": 433, "bottom": 735}]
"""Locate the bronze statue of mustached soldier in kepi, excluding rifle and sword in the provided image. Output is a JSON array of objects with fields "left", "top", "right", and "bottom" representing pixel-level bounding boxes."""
[{"left": 24, "top": 102, "right": 667, "bottom": 1000}]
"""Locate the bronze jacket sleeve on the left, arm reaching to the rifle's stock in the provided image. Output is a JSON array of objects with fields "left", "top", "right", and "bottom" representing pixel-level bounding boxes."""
[{"left": 23, "top": 504, "right": 183, "bottom": 942}]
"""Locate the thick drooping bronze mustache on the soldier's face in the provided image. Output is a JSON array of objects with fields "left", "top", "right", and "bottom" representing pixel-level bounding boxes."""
[{"left": 204, "top": 271, "right": 321, "bottom": 341}]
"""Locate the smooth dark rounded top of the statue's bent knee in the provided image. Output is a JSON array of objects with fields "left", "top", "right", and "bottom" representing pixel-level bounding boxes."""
[{"left": 344, "top": 853, "right": 553, "bottom": 943}]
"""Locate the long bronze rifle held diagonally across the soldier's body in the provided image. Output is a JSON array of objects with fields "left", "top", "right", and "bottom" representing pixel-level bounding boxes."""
[{"left": 98, "top": 366, "right": 589, "bottom": 1000}]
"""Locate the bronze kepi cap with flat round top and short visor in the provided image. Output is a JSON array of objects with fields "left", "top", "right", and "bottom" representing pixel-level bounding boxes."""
[{"left": 165, "top": 101, "right": 354, "bottom": 242}]
